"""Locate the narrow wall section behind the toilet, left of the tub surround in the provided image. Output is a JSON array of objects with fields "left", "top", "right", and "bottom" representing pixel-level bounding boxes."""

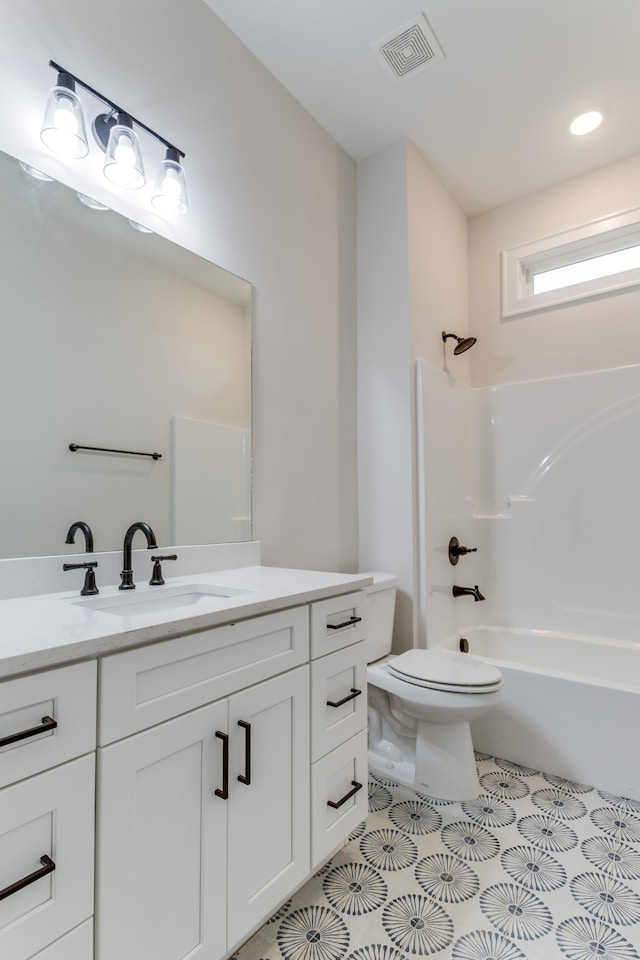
[{"left": 358, "top": 142, "right": 413, "bottom": 650}]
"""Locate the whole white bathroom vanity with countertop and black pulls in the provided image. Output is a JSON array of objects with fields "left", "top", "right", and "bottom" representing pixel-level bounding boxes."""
[{"left": 0, "top": 566, "right": 371, "bottom": 960}]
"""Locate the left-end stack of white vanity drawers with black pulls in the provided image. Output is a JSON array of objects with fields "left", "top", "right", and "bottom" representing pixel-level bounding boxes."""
[{"left": 0, "top": 662, "right": 96, "bottom": 960}]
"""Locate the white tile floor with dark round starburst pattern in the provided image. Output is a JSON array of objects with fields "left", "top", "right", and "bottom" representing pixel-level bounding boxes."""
[{"left": 234, "top": 754, "right": 640, "bottom": 960}]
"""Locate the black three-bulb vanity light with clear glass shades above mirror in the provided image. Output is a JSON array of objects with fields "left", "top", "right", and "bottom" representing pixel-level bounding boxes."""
[{"left": 40, "top": 60, "right": 188, "bottom": 216}]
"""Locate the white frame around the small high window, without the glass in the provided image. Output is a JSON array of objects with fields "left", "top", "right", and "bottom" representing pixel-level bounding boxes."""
[{"left": 501, "top": 207, "right": 640, "bottom": 319}]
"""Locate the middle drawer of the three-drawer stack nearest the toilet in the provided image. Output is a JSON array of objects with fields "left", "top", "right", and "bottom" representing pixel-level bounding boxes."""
[{"left": 311, "top": 641, "right": 367, "bottom": 760}]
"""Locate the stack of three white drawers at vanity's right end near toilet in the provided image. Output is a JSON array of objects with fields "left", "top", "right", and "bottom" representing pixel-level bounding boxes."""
[{"left": 310, "top": 591, "right": 367, "bottom": 869}]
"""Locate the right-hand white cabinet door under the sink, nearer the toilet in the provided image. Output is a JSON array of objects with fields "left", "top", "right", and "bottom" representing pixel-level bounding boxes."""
[{"left": 227, "top": 666, "right": 309, "bottom": 949}]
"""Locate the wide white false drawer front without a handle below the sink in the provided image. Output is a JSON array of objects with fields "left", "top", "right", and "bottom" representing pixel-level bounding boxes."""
[{"left": 98, "top": 606, "right": 309, "bottom": 746}]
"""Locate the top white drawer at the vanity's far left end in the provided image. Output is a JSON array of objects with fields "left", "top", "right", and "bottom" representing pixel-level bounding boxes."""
[{"left": 0, "top": 661, "right": 96, "bottom": 787}]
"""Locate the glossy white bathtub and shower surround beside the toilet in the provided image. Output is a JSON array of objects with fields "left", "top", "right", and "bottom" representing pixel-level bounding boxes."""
[{"left": 418, "top": 363, "right": 640, "bottom": 799}]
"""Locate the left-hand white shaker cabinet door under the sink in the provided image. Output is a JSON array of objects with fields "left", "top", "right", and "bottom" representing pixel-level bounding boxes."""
[{"left": 96, "top": 700, "right": 227, "bottom": 960}]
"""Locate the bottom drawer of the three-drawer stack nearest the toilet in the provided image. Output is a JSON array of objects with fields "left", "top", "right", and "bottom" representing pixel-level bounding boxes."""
[{"left": 311, "top": 730, "right": 368, "bottom": 870}]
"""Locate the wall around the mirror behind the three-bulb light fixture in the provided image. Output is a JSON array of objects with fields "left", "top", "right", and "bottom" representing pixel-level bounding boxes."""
[{"left": 0, "top": 0, "right": 357, "bottom": 571}]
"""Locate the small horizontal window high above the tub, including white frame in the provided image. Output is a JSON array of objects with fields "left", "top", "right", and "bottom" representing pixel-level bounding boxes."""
[{"left": 502, "top": 210, "right": 640, "bottom": 317}]
